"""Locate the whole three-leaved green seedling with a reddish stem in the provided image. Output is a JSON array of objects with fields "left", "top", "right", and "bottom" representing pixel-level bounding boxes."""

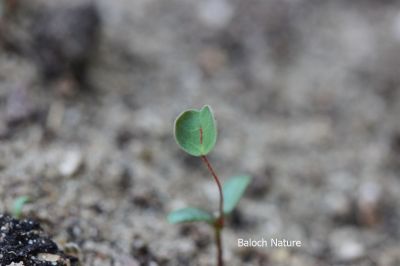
[{"left": 168, "top": 105, "right": 251, "bottom": 266}]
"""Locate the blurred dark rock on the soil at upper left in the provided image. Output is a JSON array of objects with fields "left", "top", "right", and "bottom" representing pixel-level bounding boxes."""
[{"left": 33, "top": 3, "right": 100, "bottom": 85}]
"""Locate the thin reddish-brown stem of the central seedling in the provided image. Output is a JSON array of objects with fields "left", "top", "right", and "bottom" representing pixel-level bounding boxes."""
[{"left": 201, "top": 155, "right": 224, "bottom": 266}]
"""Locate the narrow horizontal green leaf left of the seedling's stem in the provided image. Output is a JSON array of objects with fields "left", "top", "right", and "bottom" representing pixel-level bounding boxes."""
[{"left": 167, "top": 208, "right": 214, "bottom": 224}]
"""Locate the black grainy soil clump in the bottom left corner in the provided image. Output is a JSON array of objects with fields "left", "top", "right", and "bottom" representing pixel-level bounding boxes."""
[{"left": 0, "top": 214, "right": 79, "bottom": 266}]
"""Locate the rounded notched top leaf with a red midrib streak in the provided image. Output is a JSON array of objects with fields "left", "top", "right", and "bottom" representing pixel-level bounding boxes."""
[{"left": 174, "top": 105, "right": 217, "bottom": 156}]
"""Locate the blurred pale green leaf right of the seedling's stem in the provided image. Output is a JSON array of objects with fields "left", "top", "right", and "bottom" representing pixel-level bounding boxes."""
[{"left": 222, "top": 176, "right": 251, "bottom": 214}]
